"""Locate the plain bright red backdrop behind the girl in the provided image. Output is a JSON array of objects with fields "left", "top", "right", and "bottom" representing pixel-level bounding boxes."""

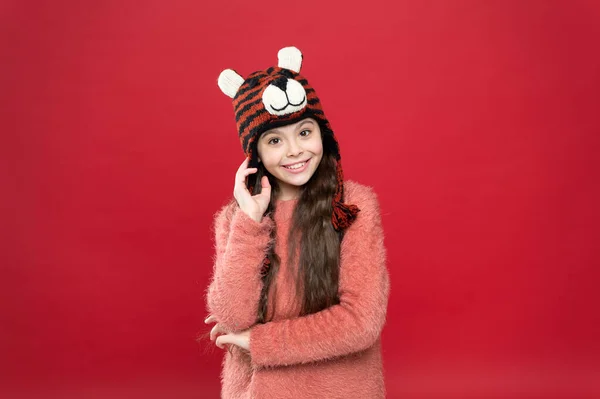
[{"left": 0, "top": 0, "right": 600, "bottom": 398}]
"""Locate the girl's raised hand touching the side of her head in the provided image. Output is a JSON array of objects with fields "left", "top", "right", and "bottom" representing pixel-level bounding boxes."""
[{"left": 233, "top": 157, "right": 271, "bottom": 222}]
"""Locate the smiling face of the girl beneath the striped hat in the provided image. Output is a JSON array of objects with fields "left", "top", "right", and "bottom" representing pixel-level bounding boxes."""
[{"left": 257, "top": 118, "right": 323, "bottom": 196}]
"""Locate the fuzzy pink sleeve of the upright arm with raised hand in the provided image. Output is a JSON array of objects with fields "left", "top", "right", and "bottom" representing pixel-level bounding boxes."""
[{"left": 206, "top": 203, "right": 274, "bottom": 332}]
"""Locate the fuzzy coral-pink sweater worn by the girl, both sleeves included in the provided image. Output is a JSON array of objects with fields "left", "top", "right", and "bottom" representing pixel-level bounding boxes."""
[{"left": 206, "top": 180, "right": 390, "bottom": 399}]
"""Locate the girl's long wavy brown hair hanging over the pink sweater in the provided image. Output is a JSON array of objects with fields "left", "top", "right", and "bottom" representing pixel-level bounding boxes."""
[{"left": 248, "top": 124, "right": 343, "bottom": 323}]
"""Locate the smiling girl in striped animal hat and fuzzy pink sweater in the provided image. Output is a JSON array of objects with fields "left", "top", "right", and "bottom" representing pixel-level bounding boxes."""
[{"left": 205, "top": 47, "right": 390, "bottom": 399}]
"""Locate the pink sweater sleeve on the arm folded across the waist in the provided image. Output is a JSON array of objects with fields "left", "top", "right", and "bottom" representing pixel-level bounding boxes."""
[{"left": 250, "top": 187, "right": 390, "bottom": 368}]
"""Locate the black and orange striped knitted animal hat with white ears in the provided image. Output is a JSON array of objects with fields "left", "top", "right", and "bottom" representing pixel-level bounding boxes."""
[{"left": 218, "top": 47, "right": 359, "bottom": 231}]
